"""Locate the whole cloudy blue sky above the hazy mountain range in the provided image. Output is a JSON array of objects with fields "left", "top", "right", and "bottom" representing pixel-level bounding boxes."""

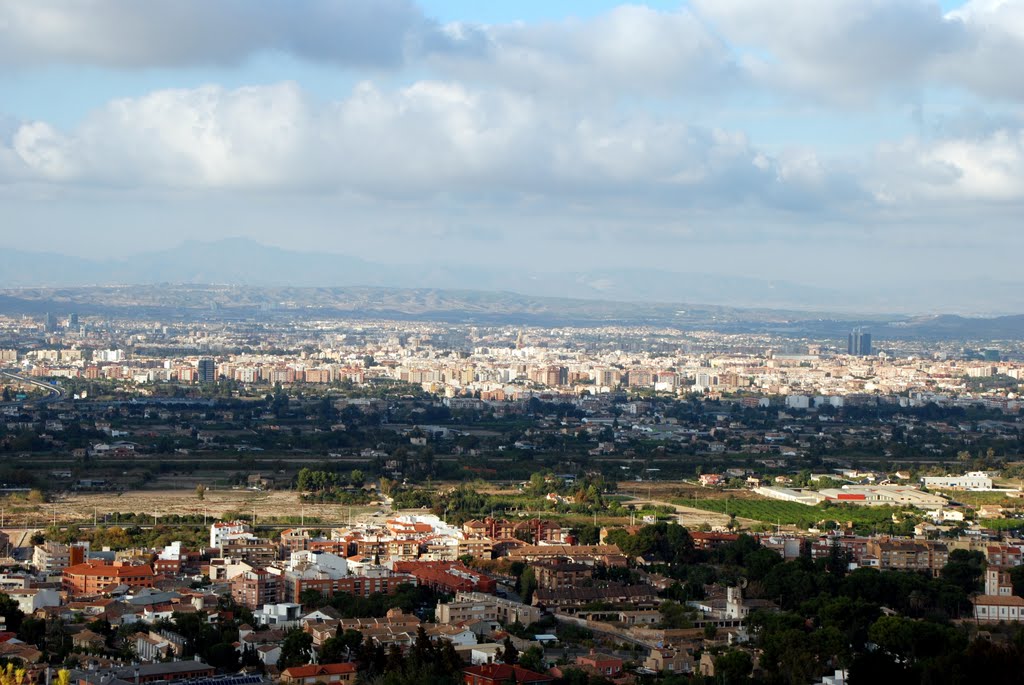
[{"left": 0, "top": 0, "right": 1024, "bottom": 303}]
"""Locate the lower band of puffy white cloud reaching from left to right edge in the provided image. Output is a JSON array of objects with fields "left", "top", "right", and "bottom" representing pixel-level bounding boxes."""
[{"left": 24, "top": 81, "right": 1024, "bottom": 216}]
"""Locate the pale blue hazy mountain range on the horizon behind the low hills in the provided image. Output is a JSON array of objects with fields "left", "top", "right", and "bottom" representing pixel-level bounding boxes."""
[{"left": 0, "top": 239, "right": 1024, "bottom": 315}]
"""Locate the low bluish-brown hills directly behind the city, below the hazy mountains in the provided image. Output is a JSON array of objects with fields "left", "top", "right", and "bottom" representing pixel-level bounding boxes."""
[{"left": 0, "top": 284, "right": 1024, "bottom": 344}]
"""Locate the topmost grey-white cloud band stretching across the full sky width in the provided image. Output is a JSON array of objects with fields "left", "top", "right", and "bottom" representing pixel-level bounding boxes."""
[{"left": 8, "top": 0, "right": 1024, "bottom": 105}]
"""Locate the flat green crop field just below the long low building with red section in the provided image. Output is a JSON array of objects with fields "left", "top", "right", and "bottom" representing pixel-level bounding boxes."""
[{"left": 675, "top": 500, "right": 905, "bottom": 528}]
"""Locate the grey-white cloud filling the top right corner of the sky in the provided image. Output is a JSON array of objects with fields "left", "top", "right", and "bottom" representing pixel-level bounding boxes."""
[{"left": 694, "top": 0, "right": 1024, "bottom": 104}]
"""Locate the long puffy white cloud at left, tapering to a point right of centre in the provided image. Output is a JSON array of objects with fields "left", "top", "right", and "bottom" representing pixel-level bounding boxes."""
[{"left": 2, "top": 81, "right": 847, "bottom": 206}]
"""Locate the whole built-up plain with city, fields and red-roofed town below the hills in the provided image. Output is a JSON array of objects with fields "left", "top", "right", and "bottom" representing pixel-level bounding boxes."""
[{"left": 0, "top": 305, "right": 1024, "bottom": 685}]
